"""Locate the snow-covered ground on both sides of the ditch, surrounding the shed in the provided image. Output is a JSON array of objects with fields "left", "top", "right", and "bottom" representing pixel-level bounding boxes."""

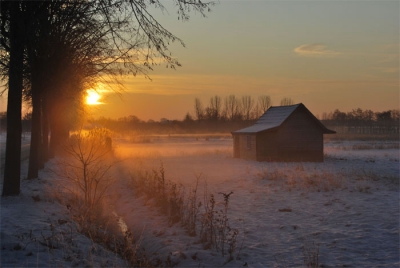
[{"left": 1, "top": 135, "right": 399, "bottom": 267}]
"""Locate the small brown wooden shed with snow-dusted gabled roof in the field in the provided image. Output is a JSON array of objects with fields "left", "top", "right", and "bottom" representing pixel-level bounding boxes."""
[{"left": 232, "top": 103, "right": 336, "bottom": 162}]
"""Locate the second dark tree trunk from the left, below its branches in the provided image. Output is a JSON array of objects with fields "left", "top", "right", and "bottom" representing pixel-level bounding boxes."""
[{"left": 28, "top": 84, "right": 42, "bottom": 179}]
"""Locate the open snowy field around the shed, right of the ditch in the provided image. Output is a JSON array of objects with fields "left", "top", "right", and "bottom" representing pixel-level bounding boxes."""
[{"left": 110, "top": 137, "right": 399, "bottom": 267}]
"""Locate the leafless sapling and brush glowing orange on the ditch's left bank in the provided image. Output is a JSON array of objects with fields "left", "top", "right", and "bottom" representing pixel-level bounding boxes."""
[{"left": 48, "top": 129, "right": 152, "bottom": 267}]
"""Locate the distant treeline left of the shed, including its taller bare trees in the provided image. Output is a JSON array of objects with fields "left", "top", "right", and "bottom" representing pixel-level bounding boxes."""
[{"left": 85, "top": 95, "right": 294, "bottom": 134}]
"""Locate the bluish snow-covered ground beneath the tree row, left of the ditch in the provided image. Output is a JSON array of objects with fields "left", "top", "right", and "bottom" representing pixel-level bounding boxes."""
[{"left": 0, "top": 162, "right": 125, "bottom": 267}]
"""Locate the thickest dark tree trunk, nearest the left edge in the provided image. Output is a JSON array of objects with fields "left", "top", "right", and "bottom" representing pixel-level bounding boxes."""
[{"left": 2, "top": 1, "right": 24, "bottom": 196}]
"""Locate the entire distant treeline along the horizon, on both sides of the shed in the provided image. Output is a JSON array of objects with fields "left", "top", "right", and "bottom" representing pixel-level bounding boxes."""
[{"left": 0, "top": 100, "right": 400, "bottom": 135}]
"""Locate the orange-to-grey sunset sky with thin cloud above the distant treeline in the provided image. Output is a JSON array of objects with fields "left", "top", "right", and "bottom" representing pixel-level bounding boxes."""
[{"left": 1, "top": 0, "right": 400, "bottom": 120}]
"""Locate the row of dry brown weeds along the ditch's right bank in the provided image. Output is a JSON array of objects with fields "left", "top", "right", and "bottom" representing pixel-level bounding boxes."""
[{"left": 131, "top": 163, "right": 239, "bottom": 259}]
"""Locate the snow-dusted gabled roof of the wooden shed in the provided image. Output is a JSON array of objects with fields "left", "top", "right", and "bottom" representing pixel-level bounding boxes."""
[{"left": 232, "top": 103, "right": 336, "bottom": 134}]
